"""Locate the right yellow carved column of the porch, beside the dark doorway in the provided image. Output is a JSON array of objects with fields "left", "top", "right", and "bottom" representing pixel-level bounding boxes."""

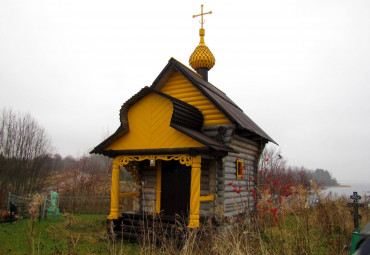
[{"left": 188, "top": 155, "right": 201, "bottom": 228}]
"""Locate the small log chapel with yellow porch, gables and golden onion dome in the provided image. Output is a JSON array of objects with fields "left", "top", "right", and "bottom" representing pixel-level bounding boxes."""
[{"left": 91, "top": 3, "right": 275, "bottom": 235}]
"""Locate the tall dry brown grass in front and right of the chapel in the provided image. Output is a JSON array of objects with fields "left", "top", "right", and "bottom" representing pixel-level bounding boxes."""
[{"left": 129, "top": 184, "right": 370, "bottom": 255}]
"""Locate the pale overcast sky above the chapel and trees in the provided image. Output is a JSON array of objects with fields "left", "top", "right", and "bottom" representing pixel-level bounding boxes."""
[{"left": 0, "top": 0, "right": 370, "bottom": 184}]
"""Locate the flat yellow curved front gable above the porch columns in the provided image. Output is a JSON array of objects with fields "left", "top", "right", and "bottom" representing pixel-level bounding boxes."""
[{"left": 105, "top": 93, "right": 206, "bottom": 150}]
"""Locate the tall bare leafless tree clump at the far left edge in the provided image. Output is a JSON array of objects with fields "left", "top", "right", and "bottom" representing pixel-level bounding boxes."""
[{"left": 0, "top": 108, "right": 51, "bottom": 195}]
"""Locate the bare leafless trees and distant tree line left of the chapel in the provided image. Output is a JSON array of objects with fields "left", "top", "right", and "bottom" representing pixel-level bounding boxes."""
[{"left": 0, "top": 108, "right": 111, "bottom": 199}]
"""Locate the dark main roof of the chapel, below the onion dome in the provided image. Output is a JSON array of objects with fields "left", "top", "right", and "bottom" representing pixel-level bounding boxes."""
[{"left": 151, "top": 58, "right": 277, "bottom": 144}]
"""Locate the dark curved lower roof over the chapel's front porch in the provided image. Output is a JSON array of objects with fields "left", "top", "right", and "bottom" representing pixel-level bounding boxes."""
[{"left": 91, "top": 87, "right": 233, "bottom": 155}]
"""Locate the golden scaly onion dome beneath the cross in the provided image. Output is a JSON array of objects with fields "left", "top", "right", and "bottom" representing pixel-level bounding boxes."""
[{"left": 189, "top": 28, "right": 216, "bottom": 70}]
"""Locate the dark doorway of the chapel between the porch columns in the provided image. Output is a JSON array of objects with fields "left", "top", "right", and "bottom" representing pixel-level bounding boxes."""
[{"left": 161, "top": 160, "right": 191, "bottom": 219}]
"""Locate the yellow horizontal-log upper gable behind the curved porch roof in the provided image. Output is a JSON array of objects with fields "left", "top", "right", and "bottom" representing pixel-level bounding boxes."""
[{"left": 161, "top": 72, "right": 231, "bottom": 126}]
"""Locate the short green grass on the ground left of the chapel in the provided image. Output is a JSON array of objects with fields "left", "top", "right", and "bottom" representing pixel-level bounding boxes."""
[{"left": 0, "top": 215, "right": 138, "bottom": 254}]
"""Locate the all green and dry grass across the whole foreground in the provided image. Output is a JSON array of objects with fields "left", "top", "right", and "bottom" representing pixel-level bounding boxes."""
[{"left": 0, "top": 188, "right": 370, "bottom": 255}]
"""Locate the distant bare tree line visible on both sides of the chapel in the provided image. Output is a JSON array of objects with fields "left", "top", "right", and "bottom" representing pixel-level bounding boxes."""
[{"left": 0, "top": 109, "right": 338, "bottom": 199}]
